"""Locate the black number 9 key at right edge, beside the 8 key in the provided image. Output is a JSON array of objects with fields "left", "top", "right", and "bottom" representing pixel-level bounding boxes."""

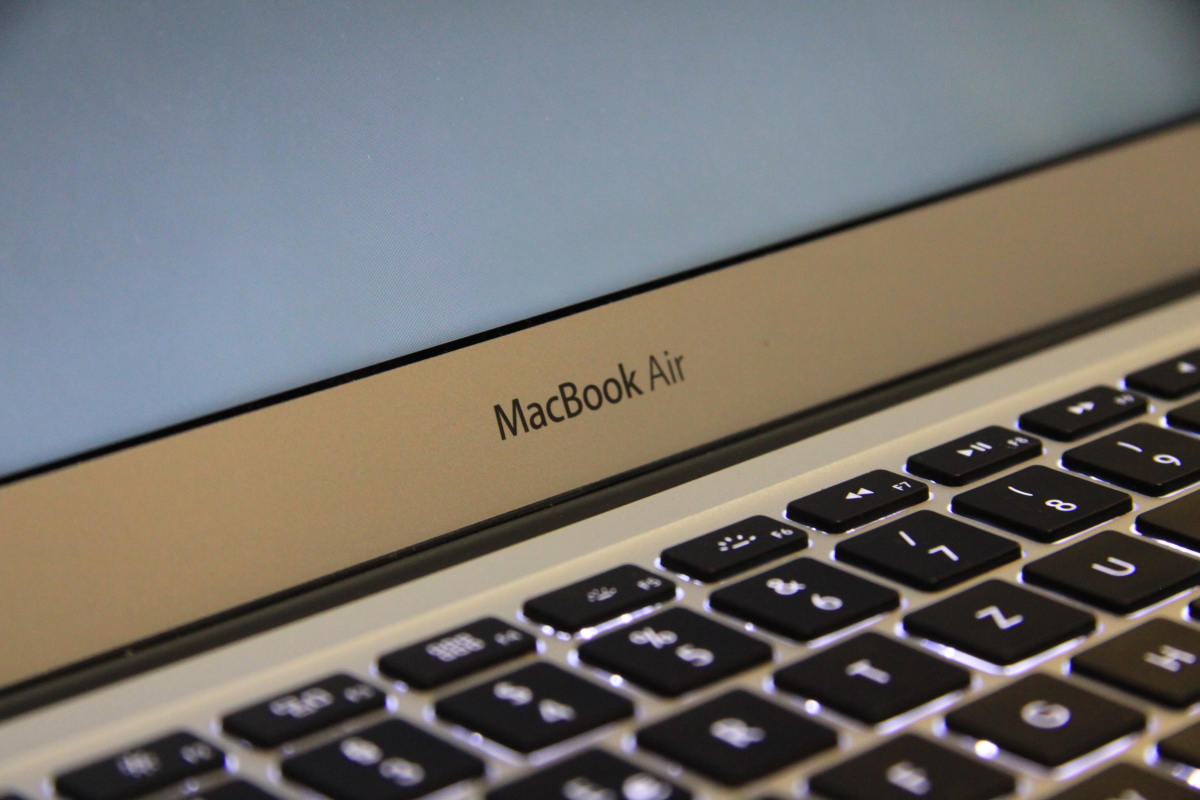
[{"left": 1062, "top": 422, "right": 1200, "bottom": 498}]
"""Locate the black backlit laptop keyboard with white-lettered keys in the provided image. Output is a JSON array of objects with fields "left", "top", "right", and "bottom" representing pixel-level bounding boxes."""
[{"left": 16, "top": 351, "right": 1200, "bottom": 800}]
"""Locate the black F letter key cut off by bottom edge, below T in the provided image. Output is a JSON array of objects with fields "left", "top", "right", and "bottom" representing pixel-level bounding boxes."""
[{"left": 809, "top": 733, "right": 1016, "bottom": 800}]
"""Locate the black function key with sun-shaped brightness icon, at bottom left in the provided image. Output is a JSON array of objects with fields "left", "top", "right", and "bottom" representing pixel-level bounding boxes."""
[{"left": 54, "top": 732, "right": 224, "bottom": 800}]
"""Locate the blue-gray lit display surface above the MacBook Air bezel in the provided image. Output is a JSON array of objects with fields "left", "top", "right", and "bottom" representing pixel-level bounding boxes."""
[{"left": 0, "top": 0, "right": 1200, "bottom": 475}]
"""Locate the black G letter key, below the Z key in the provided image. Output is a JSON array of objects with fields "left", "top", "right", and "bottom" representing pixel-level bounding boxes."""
[{"left": 946, "top": 673, "right": 1146, "bottom": 766}]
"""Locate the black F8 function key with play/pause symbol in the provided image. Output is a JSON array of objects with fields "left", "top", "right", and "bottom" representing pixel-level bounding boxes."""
[{"left": 906, "top": 425, "right": 1042, "bottom": 486}]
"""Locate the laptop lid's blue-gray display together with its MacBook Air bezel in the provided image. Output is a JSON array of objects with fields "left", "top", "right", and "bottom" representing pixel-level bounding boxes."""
[{"left": 0, "top": 2, "right": 1200, "bottom": 685}]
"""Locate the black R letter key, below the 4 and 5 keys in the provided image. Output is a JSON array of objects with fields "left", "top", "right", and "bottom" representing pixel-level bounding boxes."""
[{"left": 637, "top": 688, "right": 838, "bottom": 786}]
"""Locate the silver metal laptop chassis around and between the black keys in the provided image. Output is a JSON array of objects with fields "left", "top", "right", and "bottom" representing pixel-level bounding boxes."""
[{"left": 7, "top": 299, "right": 1200, "bottom": 800}]
